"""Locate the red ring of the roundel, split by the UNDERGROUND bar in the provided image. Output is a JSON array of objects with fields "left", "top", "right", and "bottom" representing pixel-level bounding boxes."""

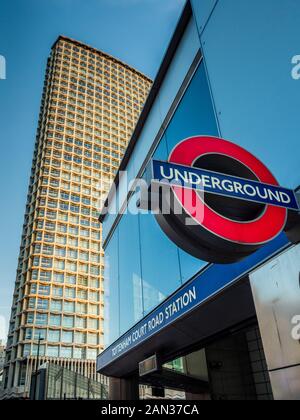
[{"left": 169, "top": 136, "right": 287, "bottom": 245}]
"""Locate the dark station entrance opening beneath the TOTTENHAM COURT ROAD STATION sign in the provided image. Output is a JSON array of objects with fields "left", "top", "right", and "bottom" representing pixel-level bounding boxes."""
[{"left": 161, "top": 324, "right": 273, "bottom": 401}]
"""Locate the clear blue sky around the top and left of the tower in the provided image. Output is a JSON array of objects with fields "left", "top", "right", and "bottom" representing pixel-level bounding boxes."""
[{"left": 0, "top": 0, "right": 185, "bottom": 340}]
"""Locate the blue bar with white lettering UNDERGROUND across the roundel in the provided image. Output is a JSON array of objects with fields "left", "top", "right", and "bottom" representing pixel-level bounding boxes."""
[{"left": 152, "top": 160, "right": 299, "bottom": 211}]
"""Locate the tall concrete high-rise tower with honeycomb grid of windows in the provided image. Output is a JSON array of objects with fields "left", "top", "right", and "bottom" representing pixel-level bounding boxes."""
[{"left": 4, "top": 36, "right": 152, "bottom": 397}]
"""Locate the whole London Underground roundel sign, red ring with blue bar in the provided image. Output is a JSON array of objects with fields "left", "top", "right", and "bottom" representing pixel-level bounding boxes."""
[{"left": 153, "top": 136, "right": 299, "bottom": 263}]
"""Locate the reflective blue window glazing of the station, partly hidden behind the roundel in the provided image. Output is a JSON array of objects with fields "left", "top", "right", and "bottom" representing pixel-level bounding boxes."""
[{"left": 105, "top": 62, "right": 218, "bottom": 345}]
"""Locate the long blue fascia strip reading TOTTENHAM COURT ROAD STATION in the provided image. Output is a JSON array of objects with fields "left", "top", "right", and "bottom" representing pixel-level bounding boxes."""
[{"left": 97, "top": 231, "right": 287, "bottom": 372}]
